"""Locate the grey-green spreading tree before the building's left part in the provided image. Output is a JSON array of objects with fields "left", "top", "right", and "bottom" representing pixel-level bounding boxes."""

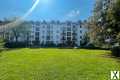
[{"left": 5, "top": 21, "right": 31, "bottom": 48}]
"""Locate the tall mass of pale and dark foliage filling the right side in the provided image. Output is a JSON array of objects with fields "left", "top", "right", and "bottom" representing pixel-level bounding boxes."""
[{"left": 90, "top": 0, "right": 120, "bottom": 48}]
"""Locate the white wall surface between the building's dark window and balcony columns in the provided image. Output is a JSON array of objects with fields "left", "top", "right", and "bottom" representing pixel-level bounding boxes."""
[{"left": 30, "top": 23, "right": 87, "bottom": 46}]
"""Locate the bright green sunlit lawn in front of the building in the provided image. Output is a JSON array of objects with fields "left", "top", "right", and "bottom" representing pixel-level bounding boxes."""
[{"left": 0, "top": 49, "right": 120, "bottom": 80}]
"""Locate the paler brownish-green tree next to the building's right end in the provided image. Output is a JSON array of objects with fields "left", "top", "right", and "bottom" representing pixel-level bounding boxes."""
[{"left": 88, "top": 0, "right": 105, "bottom": 47}]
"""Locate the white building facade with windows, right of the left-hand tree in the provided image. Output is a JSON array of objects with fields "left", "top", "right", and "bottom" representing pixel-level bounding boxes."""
[{"left": 30, "top": 22, "right": 87, "bottom": 46}]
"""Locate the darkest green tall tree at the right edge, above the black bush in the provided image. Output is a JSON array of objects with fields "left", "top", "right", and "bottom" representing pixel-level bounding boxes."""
[{"left": 104, "top": 0, "right": 120, "bottom": 45}]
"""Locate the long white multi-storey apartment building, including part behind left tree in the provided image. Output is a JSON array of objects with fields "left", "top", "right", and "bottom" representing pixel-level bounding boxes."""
[{"left": 0, "top": 21, "right": 88, "bottom": 46}]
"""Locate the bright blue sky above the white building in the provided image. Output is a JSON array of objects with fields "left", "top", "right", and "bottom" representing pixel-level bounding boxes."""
[{"left": 0, "top": 0, "right": 95, "bottom": 21}]
